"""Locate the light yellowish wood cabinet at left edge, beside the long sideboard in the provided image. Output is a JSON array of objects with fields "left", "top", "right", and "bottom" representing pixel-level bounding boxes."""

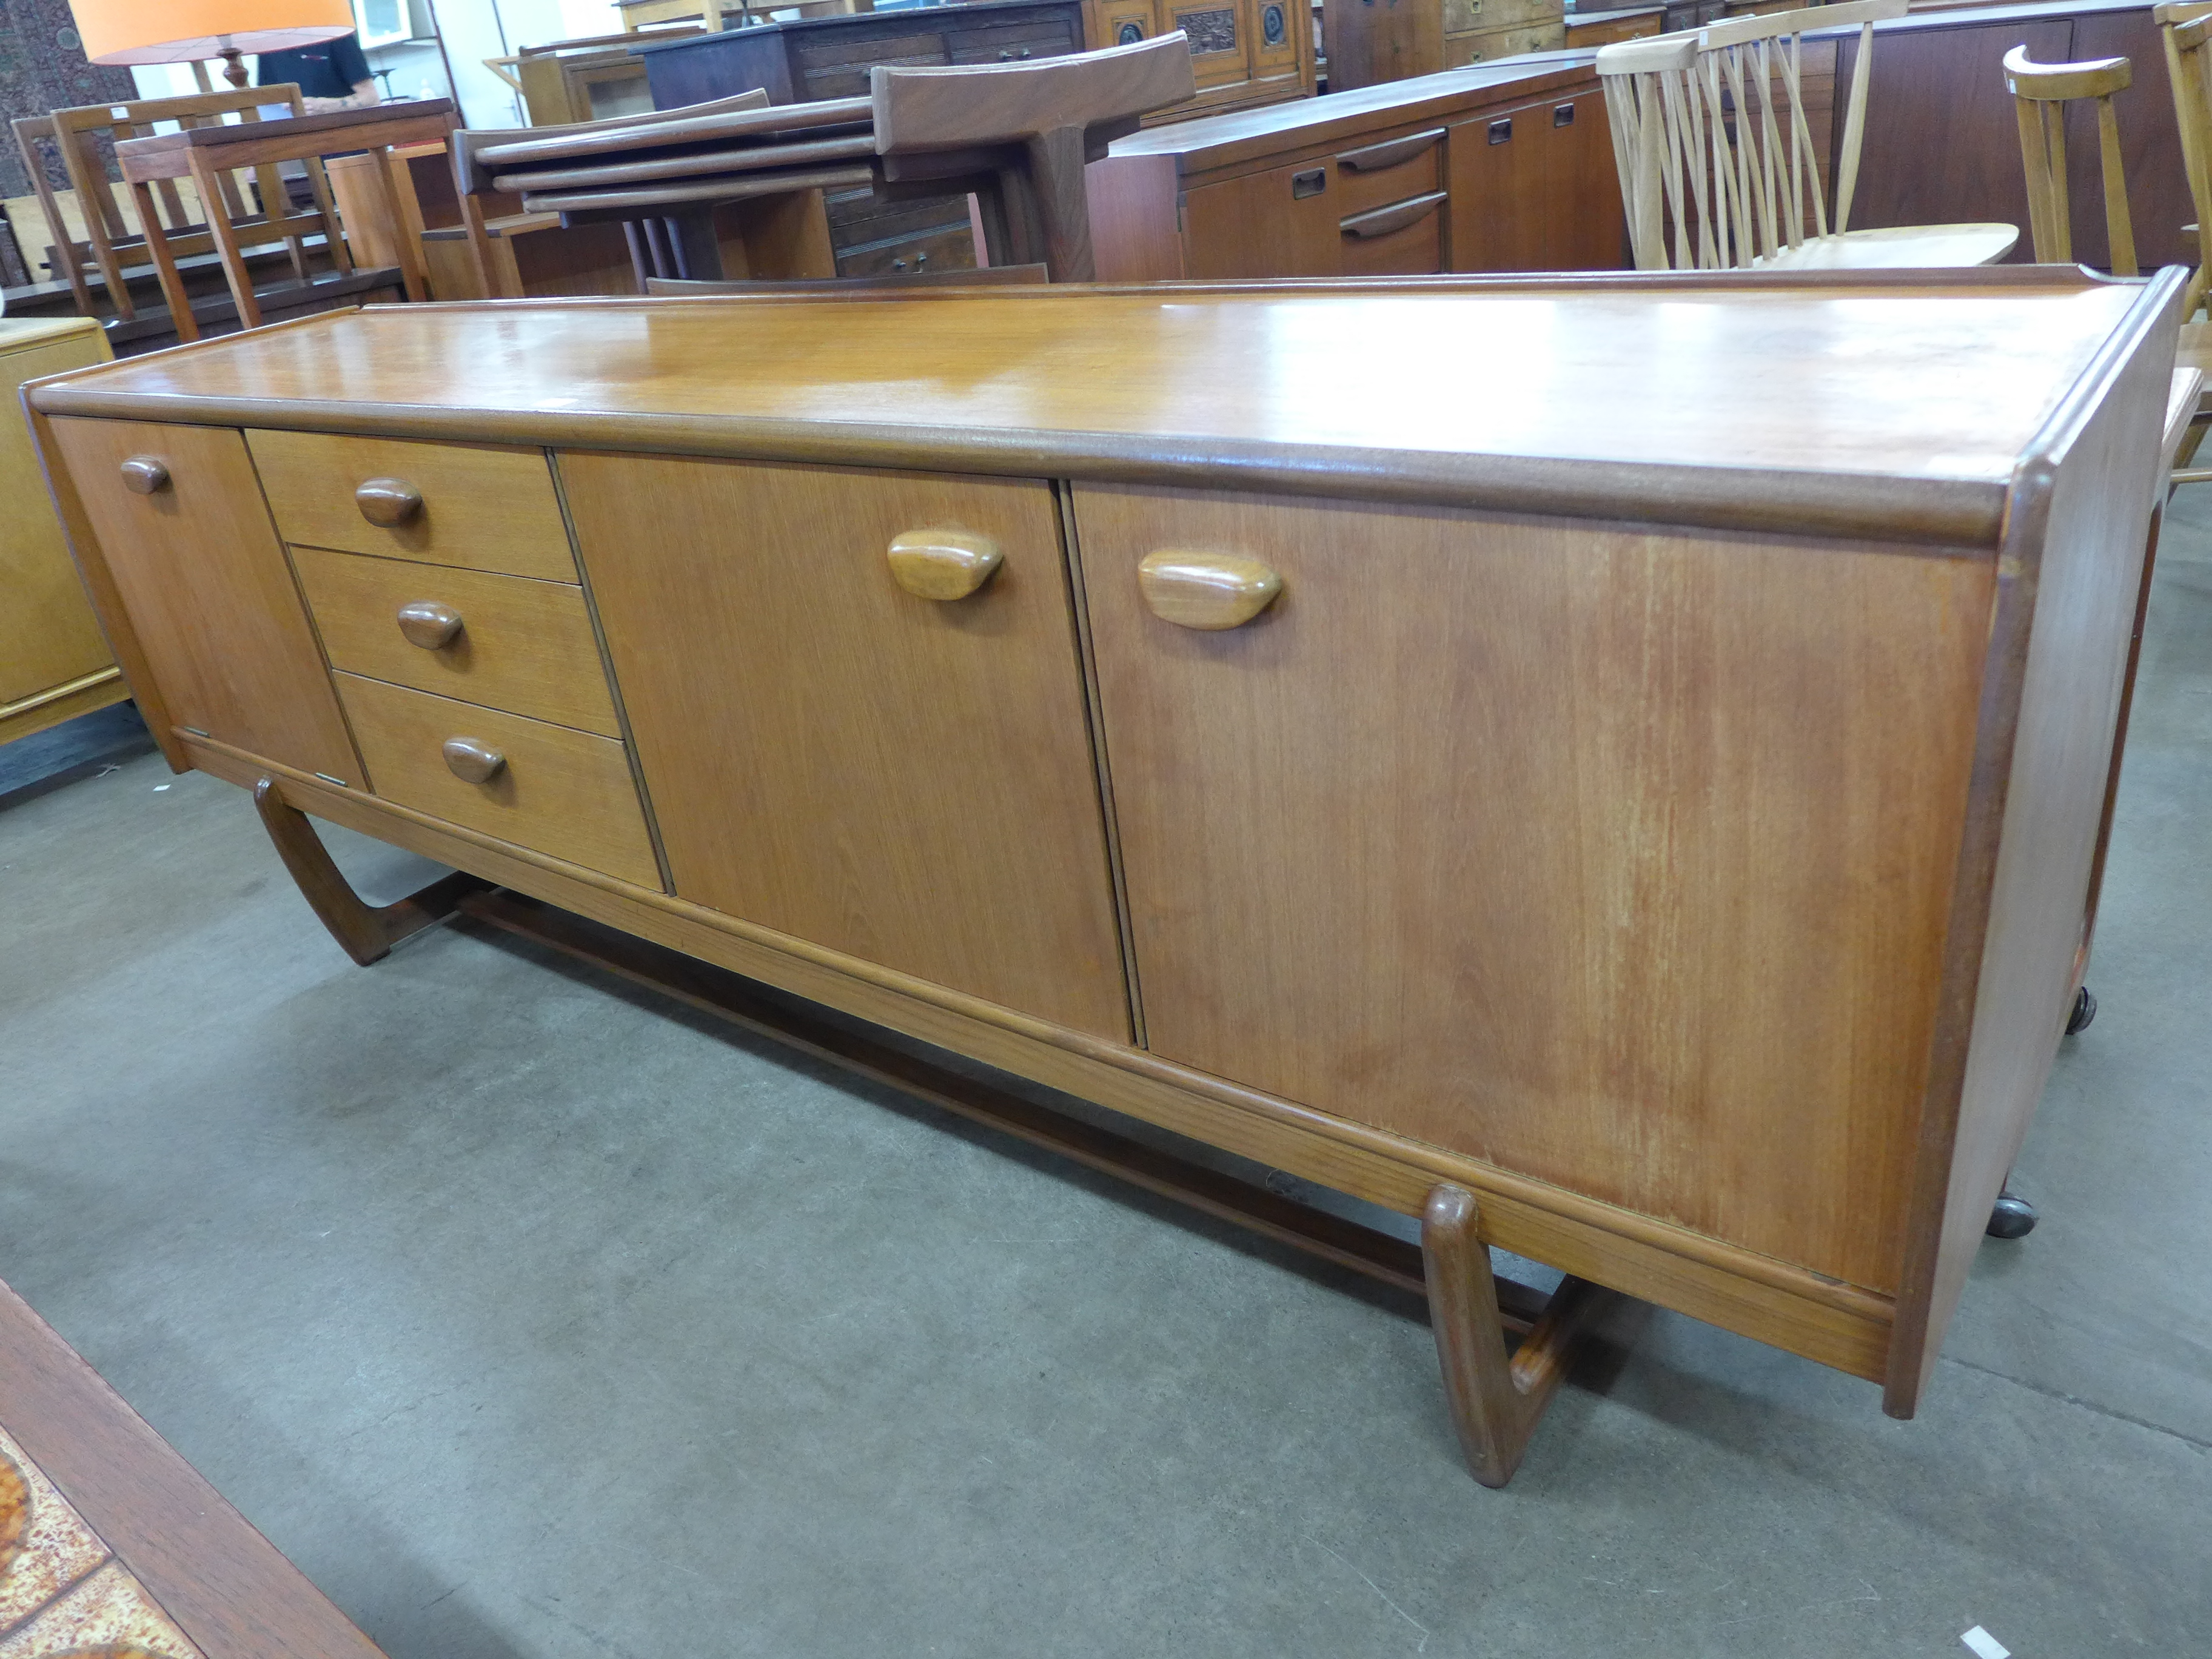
[{"left": 0, "top": 317, "right": 130, "bottom": 743}]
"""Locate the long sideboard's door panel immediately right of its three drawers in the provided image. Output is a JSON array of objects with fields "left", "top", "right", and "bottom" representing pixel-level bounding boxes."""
[{"left": 560, "top": 454, "right": 1130, "bottom": 1042}]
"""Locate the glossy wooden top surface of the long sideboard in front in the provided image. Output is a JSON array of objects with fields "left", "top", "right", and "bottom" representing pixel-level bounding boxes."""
[{"left": 33, "top": 267, "right": 2163, "bottom": 546}]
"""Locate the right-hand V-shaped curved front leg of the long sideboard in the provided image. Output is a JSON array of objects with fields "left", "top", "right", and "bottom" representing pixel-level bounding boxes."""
[{"left": 1420, "top": 1181, "right": 1610, "bottom": 1486}]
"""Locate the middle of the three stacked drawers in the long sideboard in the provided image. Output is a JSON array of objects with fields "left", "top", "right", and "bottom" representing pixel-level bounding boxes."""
[{"left": 292, "top": 546, "right": 622, "bottom": 737}]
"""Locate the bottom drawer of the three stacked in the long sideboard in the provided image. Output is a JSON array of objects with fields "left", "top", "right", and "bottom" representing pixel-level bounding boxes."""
[{"left": 336, "top": 672, "right": 662, "bottom": 889}]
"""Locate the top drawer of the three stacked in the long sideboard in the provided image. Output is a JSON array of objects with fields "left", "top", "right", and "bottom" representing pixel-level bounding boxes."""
[{"left": 246, "top": 431, "right": 577, "bottom": 581}]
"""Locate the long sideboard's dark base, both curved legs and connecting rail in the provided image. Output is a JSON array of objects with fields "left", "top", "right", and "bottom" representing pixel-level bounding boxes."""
[{"left": 255, "top": 776, "right": 1617, "bottom": 1486}]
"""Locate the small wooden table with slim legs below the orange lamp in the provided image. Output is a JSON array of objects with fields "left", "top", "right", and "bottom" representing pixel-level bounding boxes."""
[{"left": 115, "top": 98, "right": 489, "bottom": 341}]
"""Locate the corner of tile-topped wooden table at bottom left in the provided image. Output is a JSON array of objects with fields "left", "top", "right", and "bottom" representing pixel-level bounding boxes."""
[{"left": 0, "top": 1285, "right": 383, "bottom": 1659}]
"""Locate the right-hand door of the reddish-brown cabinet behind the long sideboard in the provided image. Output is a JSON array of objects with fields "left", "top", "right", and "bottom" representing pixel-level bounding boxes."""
[{"left": 1444, "top": 91, "right": 1628, "bottom": 270}]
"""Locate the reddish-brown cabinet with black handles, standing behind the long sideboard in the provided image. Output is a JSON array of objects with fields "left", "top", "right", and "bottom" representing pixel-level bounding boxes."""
[{"left": 1086, "top": 53, "right": 1628, "bottom": 281}]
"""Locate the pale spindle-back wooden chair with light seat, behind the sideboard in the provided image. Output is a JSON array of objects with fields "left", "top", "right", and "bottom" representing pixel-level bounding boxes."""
[{"left": 1597, "top": 0, "right": 2020, "bottom": 270}]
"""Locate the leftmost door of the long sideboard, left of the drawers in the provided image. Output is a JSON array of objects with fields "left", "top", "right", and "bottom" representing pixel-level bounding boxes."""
[{"left": 53, "top": 420, "right": 363, "bottom": 785}]
